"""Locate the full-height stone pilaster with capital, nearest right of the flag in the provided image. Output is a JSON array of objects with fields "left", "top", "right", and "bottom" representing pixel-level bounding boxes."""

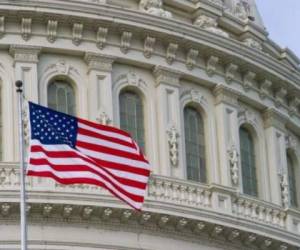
[{"left": 153, "top": 66, "right": 184, "bottom": 178}]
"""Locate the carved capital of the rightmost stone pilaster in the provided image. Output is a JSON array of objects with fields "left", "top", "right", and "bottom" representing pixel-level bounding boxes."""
[{"left": 263, "top": 108, "right": 286, "bottom": 132}]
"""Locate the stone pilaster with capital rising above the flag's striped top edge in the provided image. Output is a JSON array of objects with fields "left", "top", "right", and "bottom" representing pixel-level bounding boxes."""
[{"left": 84, "top": 53, "right": 114, "bottom": 124}]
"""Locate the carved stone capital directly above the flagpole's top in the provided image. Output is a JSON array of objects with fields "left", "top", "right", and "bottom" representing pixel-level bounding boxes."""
[{"left": 9, "top": 45, "right": 41, "bottom": 63}]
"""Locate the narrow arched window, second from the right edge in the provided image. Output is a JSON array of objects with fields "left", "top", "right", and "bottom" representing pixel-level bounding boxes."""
[{"left": 240, "top": 127, "right": 258, "bottom": 196}]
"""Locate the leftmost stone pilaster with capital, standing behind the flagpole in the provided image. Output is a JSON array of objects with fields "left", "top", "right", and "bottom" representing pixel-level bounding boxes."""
[{"left": 9, "top": 45, "right": 41, "bottom": 160}]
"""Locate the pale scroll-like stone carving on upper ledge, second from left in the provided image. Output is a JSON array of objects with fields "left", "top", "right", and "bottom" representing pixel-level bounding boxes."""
[{"left": 194, "top": 15, "right": 229, "bottom": 37}]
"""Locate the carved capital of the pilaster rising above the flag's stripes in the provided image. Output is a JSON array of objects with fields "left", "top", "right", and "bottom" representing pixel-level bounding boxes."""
[{"left": 84, "top": 52, "right": 116, "bottom": 72}]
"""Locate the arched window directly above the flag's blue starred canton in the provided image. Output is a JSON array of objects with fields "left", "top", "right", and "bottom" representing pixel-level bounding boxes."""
[{"left": 48, "top": 80, "right": 76, "bottom": 115}]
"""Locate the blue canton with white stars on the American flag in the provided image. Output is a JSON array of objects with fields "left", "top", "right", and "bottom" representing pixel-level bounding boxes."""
[{"left": 29, "top": 102, "right": 78, "bottom": 148}]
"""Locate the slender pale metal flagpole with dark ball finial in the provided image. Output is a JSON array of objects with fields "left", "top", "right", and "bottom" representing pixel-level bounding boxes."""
[{"left": 15, "top": 81, "right": 27, "bottom": 250}]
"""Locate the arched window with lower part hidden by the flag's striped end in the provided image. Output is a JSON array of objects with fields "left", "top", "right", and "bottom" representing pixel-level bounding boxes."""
[{"left": 119, "top": 90, "right": 145, "bottom": 151}]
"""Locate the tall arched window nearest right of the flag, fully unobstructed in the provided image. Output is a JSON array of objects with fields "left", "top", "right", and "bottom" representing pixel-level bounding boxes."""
[{"left": 184, "top": 107, "right": 206, "bottom": 183}]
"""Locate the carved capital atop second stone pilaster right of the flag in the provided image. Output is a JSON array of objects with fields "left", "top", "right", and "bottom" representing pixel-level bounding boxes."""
[{"left": 213, "top": 85, "right": 238, "bottom": 107}]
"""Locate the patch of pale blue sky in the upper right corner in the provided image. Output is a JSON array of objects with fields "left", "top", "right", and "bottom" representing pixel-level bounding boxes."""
[{"left": 256, "top": 0, "right": 300, "bottom": 58}]
